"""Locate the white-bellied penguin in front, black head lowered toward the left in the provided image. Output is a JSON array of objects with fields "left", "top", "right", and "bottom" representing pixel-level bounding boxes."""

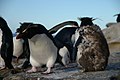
[{"left": 16, "top": 24, "right": 57, "bottom": 73}]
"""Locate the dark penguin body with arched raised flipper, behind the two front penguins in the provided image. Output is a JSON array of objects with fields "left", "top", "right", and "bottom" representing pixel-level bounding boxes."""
[{"left": 49, "top": 21, "right": 78, "bottom": 62}]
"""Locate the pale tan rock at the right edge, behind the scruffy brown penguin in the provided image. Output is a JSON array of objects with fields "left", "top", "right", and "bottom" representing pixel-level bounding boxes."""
[{"left": 102, "top": 23, "right": 120, "bottom": 53}]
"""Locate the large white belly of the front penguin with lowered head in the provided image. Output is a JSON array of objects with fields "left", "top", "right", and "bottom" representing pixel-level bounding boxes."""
[{"left": 29, "top": 34, "right": 57, "bottom": 67}]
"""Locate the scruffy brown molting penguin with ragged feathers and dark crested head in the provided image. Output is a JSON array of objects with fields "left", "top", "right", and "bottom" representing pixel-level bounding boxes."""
[{"left": 75, "top": 17, "right": 109, "bottom": 72}]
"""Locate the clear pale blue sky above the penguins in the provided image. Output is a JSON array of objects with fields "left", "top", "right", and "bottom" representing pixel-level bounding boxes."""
[{"left": 0, "top": 0, "right": 120, "bottom": 32}]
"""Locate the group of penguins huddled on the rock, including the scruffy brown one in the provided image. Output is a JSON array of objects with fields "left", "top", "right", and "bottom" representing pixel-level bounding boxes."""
[{"left": 0, "top": 13, "right": 119, "bottom": 74}]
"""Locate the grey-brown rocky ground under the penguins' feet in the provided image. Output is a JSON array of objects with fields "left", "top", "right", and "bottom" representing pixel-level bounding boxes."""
[{"left": 0, "top": 53, "right": 120, "bottom": 80}]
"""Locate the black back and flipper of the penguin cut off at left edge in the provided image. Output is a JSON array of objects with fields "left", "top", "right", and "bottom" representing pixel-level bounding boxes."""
[{"left": 0, "top": 17, "right": 16, "bottom": 74}]
